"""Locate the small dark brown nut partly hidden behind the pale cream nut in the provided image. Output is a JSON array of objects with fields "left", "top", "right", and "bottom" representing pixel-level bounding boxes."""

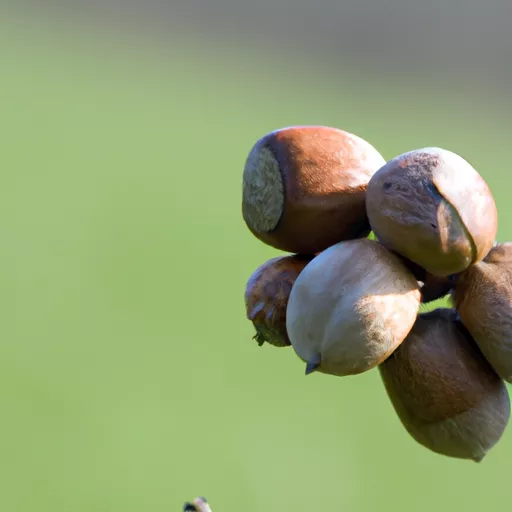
[{"left": 244, "top": 254, "right": 313, "bottom": 347}]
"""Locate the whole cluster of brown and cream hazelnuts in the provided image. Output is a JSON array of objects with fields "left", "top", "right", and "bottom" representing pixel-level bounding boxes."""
[{"left": 242, "top": 126, "right": 512, "bottom": 461}]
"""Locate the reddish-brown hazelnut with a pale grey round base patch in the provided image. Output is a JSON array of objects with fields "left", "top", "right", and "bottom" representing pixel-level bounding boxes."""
[{"left": 242, "top": 126, "right": 385, "bottom": 254}]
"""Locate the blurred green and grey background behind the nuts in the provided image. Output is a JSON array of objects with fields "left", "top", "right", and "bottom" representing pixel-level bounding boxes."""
[{"left": 7, "top": 0, "right": 512, "bottom": 512}]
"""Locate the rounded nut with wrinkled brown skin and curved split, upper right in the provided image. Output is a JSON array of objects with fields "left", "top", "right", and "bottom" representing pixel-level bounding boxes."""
[{"left": 366, "top": 148, "right": 498, "bottom": 277}]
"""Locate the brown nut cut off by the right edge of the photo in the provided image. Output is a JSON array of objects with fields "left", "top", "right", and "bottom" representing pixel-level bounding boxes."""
[{"left": 452, "top": 243, "right": 512, "bottom": 383}]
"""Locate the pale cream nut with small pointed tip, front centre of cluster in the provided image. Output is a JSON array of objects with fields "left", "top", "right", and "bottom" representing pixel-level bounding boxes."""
[{"left": 286, "top": 239, "right": 420, "bottom": 376}]
